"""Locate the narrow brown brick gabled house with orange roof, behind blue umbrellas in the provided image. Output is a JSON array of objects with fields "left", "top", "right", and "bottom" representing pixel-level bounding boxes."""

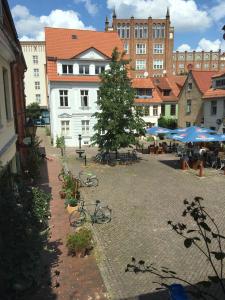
[{"left": 178, "top": 70, "right": 216, "bottom": 127}]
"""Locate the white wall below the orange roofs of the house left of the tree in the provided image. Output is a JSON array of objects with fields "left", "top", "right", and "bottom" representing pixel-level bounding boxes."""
[{"left": 50, "top": 82, "right": 99, "bottom": 147}]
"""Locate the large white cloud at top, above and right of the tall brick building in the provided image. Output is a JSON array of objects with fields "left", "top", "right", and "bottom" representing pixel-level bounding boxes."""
[{"left": 107, "top": 0, "right": 212, "bottom": 32}]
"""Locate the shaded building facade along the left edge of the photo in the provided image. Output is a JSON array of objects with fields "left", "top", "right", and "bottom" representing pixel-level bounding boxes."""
[{"left": 0, "top": 0, "right": 26, "bottom": 172}]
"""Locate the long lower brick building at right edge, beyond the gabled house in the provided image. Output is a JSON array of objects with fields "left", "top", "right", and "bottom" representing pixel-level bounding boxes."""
[{"left": 173, "top": 50, "right": 225, "bottom": 75}]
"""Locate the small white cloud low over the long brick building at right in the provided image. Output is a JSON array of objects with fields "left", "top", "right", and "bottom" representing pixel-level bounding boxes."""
[{"left": 177, "top": 38, "right": 225, "bottom": 52}]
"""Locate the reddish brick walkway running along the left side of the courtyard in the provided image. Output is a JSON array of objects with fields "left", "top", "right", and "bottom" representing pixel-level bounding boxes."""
[{"left": 32, "top": 129, "right": 107, "bottom": 300}]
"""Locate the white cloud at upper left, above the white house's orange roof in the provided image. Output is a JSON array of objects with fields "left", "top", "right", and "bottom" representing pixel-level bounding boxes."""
[{"left": 12, "top": 5, "right": 94, "bottom": 40}]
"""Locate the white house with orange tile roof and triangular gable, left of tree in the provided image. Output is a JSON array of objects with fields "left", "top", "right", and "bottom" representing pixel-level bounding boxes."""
[{"left": 45, "top": 28, "right": 123, "bottom": 147}]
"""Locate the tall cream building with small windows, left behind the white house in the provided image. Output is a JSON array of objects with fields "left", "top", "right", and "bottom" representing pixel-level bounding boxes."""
[{"left": 20, "top": 41, "right": 49, "bottom": 124}]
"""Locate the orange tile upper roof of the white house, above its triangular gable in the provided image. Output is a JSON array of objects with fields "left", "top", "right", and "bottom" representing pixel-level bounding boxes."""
[{"left": 45, "top": 27, "right": 123, "bottom": 59}]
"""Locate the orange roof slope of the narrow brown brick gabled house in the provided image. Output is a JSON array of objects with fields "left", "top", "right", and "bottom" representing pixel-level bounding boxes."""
[{"left": 191, "top": 70, "right": 217, "bottom": 94}]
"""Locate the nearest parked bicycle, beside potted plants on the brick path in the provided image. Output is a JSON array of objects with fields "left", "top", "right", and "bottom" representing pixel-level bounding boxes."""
[{"left": 69, "top": 200, "right": 112, "bottom": 227}]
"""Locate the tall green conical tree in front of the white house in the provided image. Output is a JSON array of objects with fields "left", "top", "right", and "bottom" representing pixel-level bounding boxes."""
[{"left": 92, "top": 48, "right": 145, "bottom": 152}]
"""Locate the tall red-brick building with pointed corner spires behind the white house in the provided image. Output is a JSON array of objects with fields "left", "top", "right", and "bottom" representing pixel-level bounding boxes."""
[{"left": 105, "top": 10, "right": 174, "bottom": 78}]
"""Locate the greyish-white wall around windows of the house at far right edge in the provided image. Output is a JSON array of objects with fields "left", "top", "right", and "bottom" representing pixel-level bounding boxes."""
[{"left": 203, "top": 98, "right": 225, "bottom": 133}]
